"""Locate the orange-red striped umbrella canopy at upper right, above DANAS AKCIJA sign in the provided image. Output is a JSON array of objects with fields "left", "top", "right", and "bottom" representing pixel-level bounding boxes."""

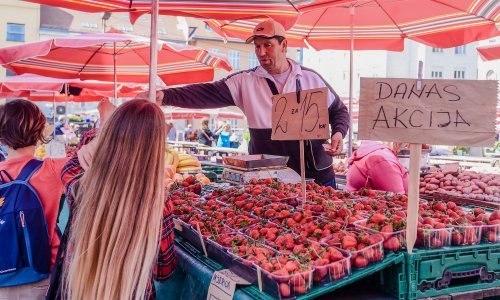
[{"left": 207, "top": 0, "right": 500, "bottom": 51}]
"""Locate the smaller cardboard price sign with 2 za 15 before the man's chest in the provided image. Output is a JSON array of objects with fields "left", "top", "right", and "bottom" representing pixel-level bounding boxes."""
[{"left": 271, "top": 87, "right": 330, "bottom": 140}]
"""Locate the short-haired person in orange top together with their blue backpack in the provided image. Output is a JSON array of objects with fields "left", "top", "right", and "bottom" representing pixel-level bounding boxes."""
[{"left": 0, "top": 99, "right": 67, "bottom": 299}]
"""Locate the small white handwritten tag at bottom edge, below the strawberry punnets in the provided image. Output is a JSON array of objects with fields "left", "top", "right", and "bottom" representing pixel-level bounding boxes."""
[{"left": 207, "top": 269, "right": 250, "bottom": 300}]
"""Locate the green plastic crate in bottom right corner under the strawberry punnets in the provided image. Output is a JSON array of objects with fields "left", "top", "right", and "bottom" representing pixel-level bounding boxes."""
[{"left": 379, "top": 244, "right": 500, "bottom": 299}]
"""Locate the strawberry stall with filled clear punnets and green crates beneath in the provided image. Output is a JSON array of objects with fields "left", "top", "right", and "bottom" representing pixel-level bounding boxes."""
[{"left": 160, "top": 173, "right": 500, "bottom": 299}]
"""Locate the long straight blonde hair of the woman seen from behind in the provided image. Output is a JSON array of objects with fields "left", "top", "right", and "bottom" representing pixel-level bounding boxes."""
[{"left": 63, "top": 100, "right": 165, "bottom": 299}]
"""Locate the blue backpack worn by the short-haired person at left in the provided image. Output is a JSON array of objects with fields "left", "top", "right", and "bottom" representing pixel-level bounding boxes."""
[{"left": 0, "top": 159, "right": 51, "bottom": 287}]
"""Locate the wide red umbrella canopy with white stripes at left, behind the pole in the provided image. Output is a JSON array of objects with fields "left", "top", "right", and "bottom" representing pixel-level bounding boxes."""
[{"left": 0, "top": 33, "right": 231, "bottom": 85}]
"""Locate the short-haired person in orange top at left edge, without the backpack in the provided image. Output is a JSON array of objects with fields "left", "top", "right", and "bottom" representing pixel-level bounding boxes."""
[{"left": 0, "top": 99, "right": 68, "bottom": 299}]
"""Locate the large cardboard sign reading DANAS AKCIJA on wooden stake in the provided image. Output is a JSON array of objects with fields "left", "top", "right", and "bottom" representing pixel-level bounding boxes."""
[{"left": 359, "top": 78, "right": 497, "bottom": 146}]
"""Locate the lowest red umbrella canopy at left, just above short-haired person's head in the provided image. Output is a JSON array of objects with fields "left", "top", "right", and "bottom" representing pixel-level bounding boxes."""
[{"left": 0, "top": 74, "right": 145, "bottom": 102}]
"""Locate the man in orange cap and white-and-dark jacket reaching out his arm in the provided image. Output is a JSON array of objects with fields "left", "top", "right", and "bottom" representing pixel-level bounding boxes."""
[{"left": 150, "top": 19, "right": 349, "bottom": 186}]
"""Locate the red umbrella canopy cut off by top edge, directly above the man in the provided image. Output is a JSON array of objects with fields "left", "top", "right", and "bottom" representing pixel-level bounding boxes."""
[{"left": 25, "top": 0, "right": 356, "bottom": 28}]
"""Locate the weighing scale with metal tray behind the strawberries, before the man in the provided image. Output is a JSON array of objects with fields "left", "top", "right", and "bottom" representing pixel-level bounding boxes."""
[{"left": 222, "top": 154, "right": 300, "bottom": 184}]
